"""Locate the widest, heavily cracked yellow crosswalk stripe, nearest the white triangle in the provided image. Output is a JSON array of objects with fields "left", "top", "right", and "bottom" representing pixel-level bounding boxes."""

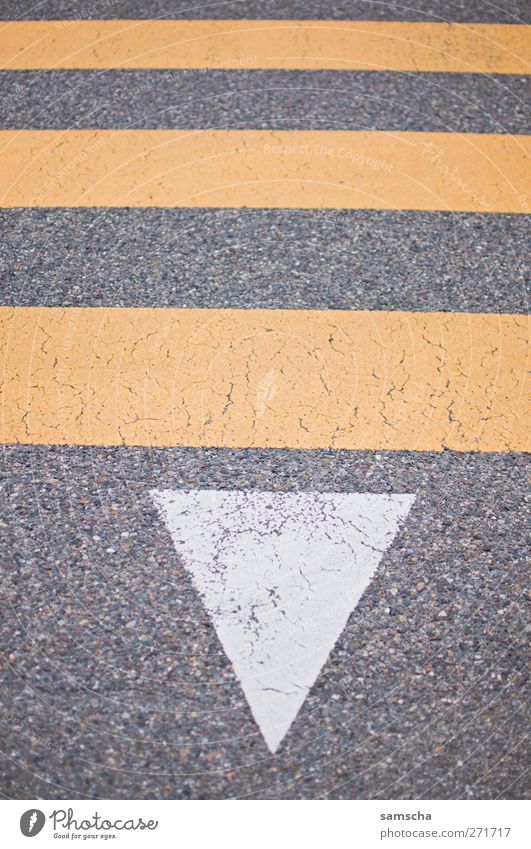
[{"left": 0, "top": 307, "right": 529, "bottom": 451}]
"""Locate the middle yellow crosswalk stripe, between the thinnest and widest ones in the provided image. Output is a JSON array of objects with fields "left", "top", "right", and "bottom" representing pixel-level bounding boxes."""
[{"left": 0, "top": 130, "right": 531, "bottom": 212}]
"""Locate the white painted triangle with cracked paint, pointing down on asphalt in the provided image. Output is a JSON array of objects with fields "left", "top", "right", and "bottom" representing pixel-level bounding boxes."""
[{"left": 152, "top": 490, "right": 415, "bottom": 752}]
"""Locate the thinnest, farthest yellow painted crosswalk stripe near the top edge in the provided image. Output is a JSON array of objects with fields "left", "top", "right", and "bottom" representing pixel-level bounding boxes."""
[{"left": 0, "top": 20, "right": 531, "bottom": 74}]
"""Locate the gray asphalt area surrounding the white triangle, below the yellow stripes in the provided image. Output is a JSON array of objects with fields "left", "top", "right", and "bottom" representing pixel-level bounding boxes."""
[{"left": 0, "top": 447, "right": 529, "bottom": 799}]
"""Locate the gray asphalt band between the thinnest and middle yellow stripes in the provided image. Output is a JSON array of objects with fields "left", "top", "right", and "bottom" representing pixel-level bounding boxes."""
[{"left": 0, "top": 70, "right": 531, "bottom": 133}]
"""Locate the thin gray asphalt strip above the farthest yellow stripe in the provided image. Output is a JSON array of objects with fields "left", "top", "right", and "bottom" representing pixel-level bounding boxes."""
[{"left": 2, "top": 0, "right": 531, "bottom": 24}]
